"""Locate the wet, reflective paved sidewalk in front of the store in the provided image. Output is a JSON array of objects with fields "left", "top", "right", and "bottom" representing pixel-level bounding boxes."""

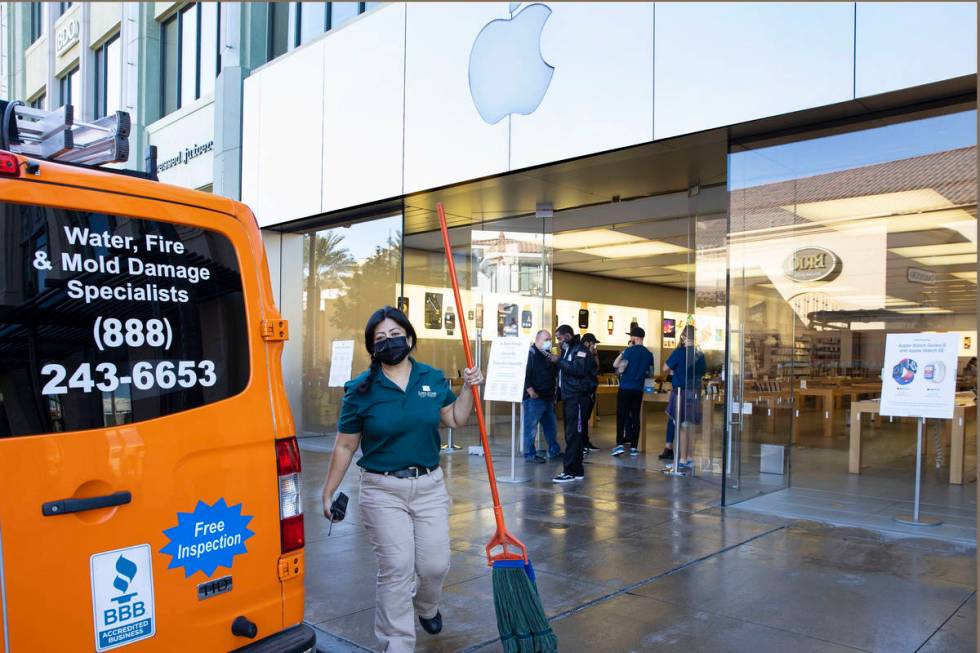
[{"left": 301, "top": 438, "right": 977, "bottom": 653}]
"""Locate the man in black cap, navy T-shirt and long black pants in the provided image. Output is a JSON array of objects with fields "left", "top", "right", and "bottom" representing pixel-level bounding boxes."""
[{"left": 610, "top": 325, "right": 653, "bottom": 456}]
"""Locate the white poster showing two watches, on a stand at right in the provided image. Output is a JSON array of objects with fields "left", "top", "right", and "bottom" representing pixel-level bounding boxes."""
[{"left": 881, "top": 333, "right": 960, "bottom": 419}]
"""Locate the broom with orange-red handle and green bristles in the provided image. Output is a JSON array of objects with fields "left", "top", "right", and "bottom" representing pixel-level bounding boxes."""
[{"left": 436, "top": 202, "right": 558, "bottom": 653}]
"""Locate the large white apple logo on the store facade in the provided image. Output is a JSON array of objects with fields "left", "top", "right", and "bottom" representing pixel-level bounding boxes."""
[{"left": 470, "top": 2, "right": 555, "bottom": 125}]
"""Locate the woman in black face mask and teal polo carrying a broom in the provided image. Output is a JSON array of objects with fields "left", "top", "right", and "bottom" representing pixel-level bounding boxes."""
[{"left": 323, "top": 306, "right": 483, "bottom": 653}]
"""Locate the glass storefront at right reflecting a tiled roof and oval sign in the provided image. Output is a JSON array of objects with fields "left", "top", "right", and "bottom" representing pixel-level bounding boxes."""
[{"left": 726, "top": 107, "right": 977, "bottom": 504}]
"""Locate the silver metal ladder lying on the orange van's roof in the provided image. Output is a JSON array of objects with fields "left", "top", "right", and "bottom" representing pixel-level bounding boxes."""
[{"left": 0, "top": 100, "right": 130, "bottom": 166}]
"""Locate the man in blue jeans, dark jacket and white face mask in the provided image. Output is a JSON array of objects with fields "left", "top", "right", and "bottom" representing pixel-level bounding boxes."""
[{"left": 523, "top": 329, "right": 561, "bottom": 463}]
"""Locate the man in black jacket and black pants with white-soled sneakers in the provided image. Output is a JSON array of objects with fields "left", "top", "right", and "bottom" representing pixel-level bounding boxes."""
[{"left": 552, "top": 324, "right": 596, "bottom": 483}]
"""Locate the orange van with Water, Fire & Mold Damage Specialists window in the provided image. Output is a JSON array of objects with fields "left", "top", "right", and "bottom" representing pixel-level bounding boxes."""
[{"left": 0, "top": 104, "right": 315, "bottom": 653}]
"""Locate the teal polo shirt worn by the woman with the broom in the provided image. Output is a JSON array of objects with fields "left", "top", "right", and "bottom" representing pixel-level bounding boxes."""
[{"left": 337, "top": 359, "right": 456, "bottom": 472}]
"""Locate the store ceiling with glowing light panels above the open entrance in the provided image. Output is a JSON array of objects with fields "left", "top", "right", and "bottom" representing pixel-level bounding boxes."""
[{"left": 405, "top": 130, "right": 728, "bottom": 288}]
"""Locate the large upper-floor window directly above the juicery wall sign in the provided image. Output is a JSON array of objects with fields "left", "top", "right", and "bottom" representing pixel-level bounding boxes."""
[{"left": 160, "top": 2, "right": 221, "bottom": 115}]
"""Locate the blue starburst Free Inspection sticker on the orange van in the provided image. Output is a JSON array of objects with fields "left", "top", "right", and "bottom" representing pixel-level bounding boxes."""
[{"left": 160, "top": 498, "right": 255, "bottom": 578}]
